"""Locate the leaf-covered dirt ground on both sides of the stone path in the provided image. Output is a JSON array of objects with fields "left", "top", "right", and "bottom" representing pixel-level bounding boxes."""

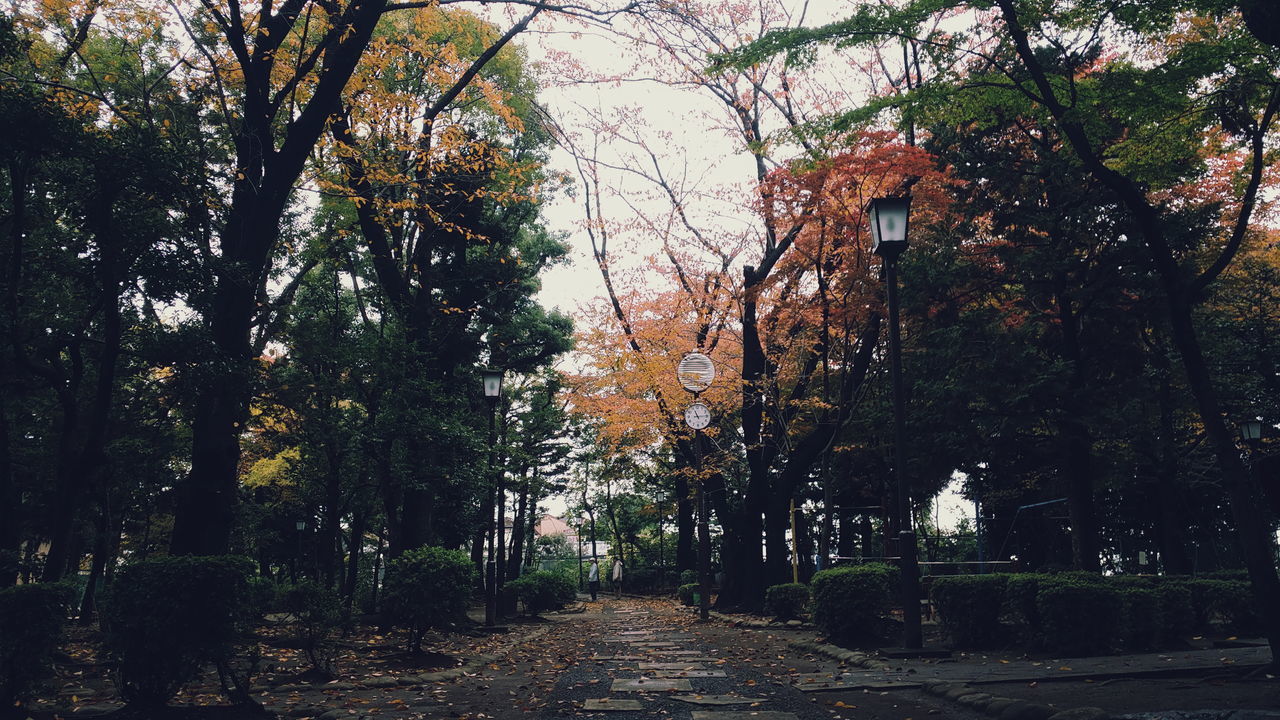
[{"left": 20, "top": 598, "right": 1280, "bottom": 720}]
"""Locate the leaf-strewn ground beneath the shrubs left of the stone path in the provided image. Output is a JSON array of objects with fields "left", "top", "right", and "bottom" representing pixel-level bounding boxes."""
[{"left": 29, "top": 599, "right": 590, "bottom": 720}]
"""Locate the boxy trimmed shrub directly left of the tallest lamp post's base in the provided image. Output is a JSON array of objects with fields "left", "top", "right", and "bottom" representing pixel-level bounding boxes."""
[{"left": 812, "top": 562, "right": 897, "bottom": 643}]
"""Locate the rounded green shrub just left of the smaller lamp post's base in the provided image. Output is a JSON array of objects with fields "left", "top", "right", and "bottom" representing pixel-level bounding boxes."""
[{"left": 383, "top": 547, "right": 475, "bottom": 653}]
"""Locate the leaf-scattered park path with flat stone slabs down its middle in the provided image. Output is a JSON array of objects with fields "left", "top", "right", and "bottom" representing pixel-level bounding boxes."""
[{"left": 538, "top": 598, "right": 973, "bottom": 720}]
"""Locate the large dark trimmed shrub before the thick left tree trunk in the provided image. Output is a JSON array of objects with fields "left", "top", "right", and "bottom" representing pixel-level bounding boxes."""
[{"left": 102, "top": 556, "right": 253, "bottom": 707}]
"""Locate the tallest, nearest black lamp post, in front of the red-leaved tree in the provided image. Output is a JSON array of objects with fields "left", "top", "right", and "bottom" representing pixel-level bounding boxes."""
[{"left": 868, "top": 197, "right": 923, "bottom": 650}]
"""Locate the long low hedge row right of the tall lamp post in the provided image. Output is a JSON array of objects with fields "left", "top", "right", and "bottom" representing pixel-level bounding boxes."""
[{"left": 932, "top": 573, "right": 1258, "bottom": 655}]
